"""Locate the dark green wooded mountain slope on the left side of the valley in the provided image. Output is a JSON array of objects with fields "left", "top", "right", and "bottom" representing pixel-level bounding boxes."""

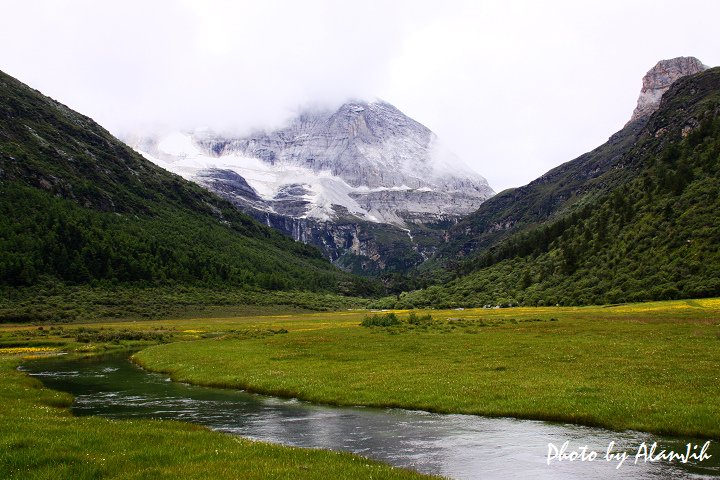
[{"left": 0, "top": 67, "right": 368, "bottom": 302}]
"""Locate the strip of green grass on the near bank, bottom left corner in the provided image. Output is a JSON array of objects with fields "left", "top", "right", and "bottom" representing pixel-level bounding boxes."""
[{"left": 0, "top": 347, "right": 428, "bottom": 480}]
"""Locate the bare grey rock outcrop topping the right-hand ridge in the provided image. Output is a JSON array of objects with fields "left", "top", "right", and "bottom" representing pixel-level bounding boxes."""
[{"left": 628, "top": 57, "right": 708, "bottom": 123}]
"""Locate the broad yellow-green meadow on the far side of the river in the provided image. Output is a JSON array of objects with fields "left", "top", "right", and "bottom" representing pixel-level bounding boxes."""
[{"left": 135, "top": 299, "right": 720, "bottom": 438}]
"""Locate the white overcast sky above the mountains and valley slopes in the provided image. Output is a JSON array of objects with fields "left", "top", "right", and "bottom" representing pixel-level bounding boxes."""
[{"left": 0, "top": 0, "right": 720, "bottom": 191}]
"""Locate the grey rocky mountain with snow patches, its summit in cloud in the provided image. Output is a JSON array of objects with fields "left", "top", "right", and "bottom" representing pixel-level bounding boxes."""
[{"left": 128, "top": 101, "right": 494, "bottom": 274}]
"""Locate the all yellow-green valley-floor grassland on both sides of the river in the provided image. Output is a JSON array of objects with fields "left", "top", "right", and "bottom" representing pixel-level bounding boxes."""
[{"left": 0, "top": 299, "right": 720, "bottom": 479}]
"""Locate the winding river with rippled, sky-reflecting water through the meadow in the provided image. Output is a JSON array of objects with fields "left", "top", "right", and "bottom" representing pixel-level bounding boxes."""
[{"left": 21, "top": 353, "right": 720, "bottom": 480}]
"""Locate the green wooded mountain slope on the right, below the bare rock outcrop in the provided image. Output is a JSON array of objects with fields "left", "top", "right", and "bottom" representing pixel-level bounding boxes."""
[{"left": 386, "top": 68, "right": 720, "bottom": 306}]
